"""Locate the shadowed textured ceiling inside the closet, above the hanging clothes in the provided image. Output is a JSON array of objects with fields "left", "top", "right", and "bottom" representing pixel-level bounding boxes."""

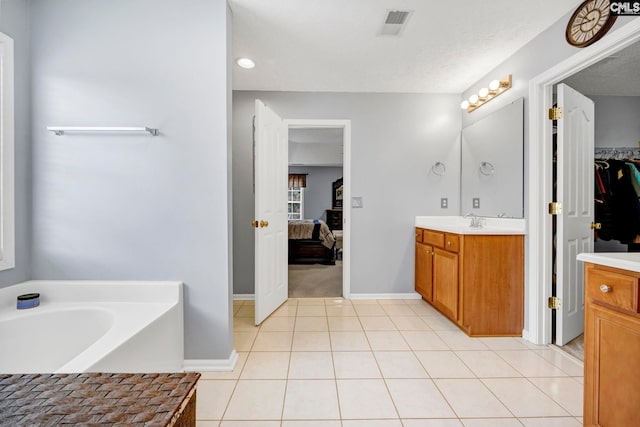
[{"left": 564, "top": 43, "right": 640, "bottom": 96}]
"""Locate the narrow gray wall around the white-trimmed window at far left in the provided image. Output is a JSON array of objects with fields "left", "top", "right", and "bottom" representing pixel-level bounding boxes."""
[{"left": 0, "top": 0, "right": 31, "bottom": 287}]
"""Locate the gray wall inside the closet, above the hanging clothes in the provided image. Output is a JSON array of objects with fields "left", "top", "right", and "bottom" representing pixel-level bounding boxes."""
[{"left": 588, "top": 95, "right": 640, "bottom": 147}]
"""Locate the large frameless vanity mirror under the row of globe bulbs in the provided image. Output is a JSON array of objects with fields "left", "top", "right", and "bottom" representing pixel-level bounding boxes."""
[{"left": 460, "top": 98, "right": 524, "bottom": 218}]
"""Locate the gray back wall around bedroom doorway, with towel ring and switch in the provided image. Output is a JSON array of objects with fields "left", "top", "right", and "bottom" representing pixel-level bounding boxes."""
[{"left": 233, "top": 91, "right": 461, "bottom": 294}]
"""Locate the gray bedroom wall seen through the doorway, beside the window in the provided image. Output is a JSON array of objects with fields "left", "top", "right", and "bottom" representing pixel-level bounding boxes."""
[{"left": 289, "top": 166, "right": 342, "bottom": 220}]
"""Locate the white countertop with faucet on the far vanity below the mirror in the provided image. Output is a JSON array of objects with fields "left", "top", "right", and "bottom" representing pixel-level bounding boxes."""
[{"left": 415, "top": 216, "right": 526, "bottom": 235}]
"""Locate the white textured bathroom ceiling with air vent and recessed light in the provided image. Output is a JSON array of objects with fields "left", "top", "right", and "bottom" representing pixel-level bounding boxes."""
[{"left": 229, "top": 0, "right": 580, "bottom": 93}]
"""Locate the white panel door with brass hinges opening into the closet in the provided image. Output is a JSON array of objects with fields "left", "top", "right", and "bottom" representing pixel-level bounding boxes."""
[{"left": 556, "top": 84, "right": 595, "bottom": 345}]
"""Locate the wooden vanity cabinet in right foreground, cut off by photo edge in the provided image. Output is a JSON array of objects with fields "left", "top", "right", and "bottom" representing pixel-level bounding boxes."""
[{"left": 584, "top": 263, "right": 640, "bottom": 427}]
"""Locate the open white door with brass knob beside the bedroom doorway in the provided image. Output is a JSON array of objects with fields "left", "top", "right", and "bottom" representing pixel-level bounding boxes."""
[{"left": 253, "top": 99, "right": 289, "bottom": 325}]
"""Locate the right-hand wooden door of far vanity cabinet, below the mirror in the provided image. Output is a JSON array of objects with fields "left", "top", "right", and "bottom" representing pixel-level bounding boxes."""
[{"left": 433, "top": 248, "right": 458, "bottom": 321}]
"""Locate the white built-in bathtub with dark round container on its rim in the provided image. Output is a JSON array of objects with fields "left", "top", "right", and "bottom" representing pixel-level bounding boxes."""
[{"left": 0, "top": 280, "right": 184, "bottom": 373}]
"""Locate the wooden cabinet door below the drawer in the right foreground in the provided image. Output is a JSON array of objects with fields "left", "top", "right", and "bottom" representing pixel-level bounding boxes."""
[{"left": 584, "top": 304, "right": 640, "bottom": 427}]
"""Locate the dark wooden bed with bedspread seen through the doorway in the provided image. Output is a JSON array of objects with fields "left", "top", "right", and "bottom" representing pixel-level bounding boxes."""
[{"left": 289, "top": 219, "right": 336, "bottom": 265}]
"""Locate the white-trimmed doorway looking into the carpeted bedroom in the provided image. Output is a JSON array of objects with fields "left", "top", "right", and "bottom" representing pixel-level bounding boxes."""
[{"left": 285, "top": 119, "right": 351, "bottom": 298}]
